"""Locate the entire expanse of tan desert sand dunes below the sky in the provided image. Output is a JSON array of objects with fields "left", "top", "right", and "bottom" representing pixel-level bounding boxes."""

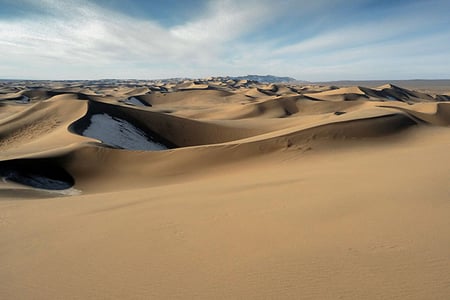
[{"left": 0, "top": 78, "right": 450, "bottom": 299}]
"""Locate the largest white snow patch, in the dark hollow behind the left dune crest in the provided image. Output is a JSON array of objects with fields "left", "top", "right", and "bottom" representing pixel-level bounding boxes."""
[{"left": 83, "top": 114, "right": 168, "bottom": 151}]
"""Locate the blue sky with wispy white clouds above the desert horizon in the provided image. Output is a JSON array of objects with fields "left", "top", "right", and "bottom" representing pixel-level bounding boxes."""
[{"left": 0, "top": 0, "right": 450, "bottom": 81}]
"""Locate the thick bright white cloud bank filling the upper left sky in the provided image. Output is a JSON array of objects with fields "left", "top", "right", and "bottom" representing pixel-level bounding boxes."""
[{"left": 0, "top": 0, "right": 280, "bottom": 75}]
